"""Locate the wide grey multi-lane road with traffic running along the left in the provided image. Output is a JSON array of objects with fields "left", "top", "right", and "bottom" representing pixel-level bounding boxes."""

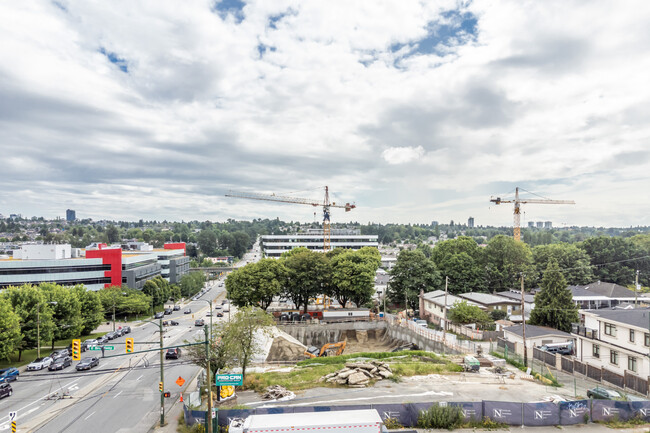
[{"left": 0, "top": 281, "right": 228, "bottom": 433}]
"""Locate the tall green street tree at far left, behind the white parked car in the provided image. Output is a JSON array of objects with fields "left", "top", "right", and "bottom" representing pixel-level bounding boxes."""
[{"left": 2, "top": 284, "right": 54, "bottom": 361}]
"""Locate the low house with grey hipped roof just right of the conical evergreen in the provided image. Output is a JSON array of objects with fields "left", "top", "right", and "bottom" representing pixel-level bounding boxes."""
[{"left": 568, "top": 281, "right": 648, "bottom": 310}]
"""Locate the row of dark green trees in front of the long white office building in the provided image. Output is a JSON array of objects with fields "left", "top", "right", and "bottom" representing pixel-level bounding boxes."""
[{"left": 226, "top": 247, "right": 381, "bottom": 311}]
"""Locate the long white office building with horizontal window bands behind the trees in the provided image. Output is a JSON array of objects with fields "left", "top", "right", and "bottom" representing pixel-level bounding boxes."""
[{"left": 260, "top": 229, "right": 379, "bottom": 258}]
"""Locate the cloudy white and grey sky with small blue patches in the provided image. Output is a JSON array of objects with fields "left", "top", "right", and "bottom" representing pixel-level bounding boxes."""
[{"left": 0, "top": 0, "right": 650, "bottom": 227}]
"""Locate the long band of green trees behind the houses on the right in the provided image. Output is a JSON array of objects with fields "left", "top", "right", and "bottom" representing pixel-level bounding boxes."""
[{"left": 389, "top": 235, "right": 650, "bottom": 308}]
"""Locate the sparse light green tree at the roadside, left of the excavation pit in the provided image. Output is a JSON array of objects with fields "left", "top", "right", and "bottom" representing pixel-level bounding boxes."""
[{"left": 223, "top": 307, "right": 275, "bottom": 378}]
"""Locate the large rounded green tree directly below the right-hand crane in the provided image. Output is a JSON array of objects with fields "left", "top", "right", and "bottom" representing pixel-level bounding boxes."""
[{"left": 485, "top": 235, "right": 536, "bottom": 292}]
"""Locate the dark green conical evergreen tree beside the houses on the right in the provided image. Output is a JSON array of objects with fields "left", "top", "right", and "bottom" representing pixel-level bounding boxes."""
[{"left": 530, "top": 259, "right": 578, "bottom": 332}]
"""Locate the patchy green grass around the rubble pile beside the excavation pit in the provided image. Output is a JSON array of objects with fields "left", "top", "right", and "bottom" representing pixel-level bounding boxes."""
[{"left": 244, "top": 351, "right": 462, "bottom": 392}]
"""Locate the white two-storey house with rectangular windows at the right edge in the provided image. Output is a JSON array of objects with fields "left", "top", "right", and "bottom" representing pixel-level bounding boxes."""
[{"left": 572, "top": 308, "right": 650, "bottom": 378}]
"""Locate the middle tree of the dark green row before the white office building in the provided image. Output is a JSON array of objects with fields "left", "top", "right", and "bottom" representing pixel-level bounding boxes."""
[{"left": 282, "top": 248, "right": 328, "bottom": 313}]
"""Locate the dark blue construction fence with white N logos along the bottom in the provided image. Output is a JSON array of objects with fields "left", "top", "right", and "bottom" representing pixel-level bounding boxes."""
[{"left": 199, "top": 400, "right": 650, "bottom": 427}]
